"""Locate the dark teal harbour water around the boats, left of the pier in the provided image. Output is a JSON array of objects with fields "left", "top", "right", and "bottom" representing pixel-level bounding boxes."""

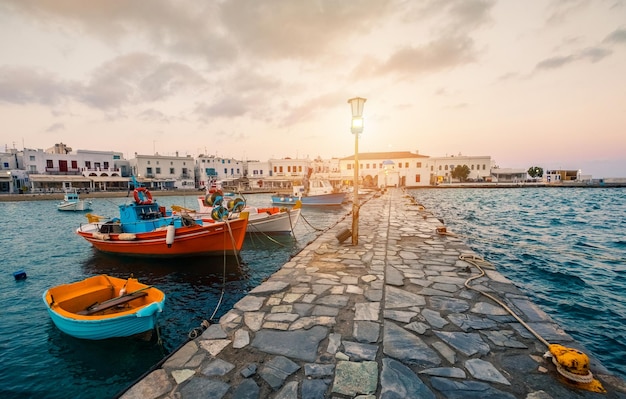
[{"left": 0, "top": 194, "right": 348, "bottom": 399}]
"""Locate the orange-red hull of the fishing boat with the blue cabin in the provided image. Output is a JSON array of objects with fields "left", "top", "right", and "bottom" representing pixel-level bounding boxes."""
[{"left": 76, "top": 218, "right": 248, "bottom": 258}]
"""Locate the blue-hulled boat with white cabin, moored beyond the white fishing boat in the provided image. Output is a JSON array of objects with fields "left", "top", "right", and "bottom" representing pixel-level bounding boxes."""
[{"left": 272, "top": 179, "right": 346, "bottom": 206}]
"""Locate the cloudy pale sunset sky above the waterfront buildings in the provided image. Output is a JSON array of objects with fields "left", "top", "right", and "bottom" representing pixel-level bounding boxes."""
[{"left": 0, "top": 0, "right": 626, "bottom": 178}]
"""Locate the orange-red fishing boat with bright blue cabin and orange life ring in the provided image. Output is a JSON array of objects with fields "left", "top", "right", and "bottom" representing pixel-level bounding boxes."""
[{"left": 76, "top": 177, "right": 248, "bottom": 257}]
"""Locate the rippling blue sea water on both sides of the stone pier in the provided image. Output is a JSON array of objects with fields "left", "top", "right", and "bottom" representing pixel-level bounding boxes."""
[{"left": 0, "top": 188, "right": 626, "bottom": 398}]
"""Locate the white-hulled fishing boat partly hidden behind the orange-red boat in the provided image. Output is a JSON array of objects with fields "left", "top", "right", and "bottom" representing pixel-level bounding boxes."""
[{"left": 189, "top": 191, "right": 302, "bottom": 234}]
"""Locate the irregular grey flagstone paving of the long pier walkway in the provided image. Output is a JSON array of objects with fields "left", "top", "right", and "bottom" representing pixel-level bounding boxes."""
[{"left": 122, "top": 189, "right": 626, "bottom": 399}]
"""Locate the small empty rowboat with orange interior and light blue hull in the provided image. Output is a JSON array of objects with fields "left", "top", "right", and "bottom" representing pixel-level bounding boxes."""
[{"left": 43, "top": 274, "right": 165, "bottom": 340}]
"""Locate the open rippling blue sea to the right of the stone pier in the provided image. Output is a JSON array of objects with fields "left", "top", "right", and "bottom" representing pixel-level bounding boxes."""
[{"left": 410, "top": 188, "right": 626, "bottom": 378}]
